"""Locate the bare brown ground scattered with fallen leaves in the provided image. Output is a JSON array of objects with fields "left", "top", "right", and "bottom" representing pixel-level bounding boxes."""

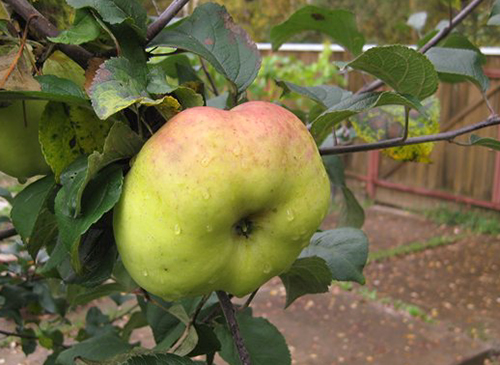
[{"left": 0, "top": 206, "right": 500, "bottom": 365}]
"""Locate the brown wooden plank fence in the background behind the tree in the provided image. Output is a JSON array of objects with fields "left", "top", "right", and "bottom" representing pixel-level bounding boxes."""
[{"left": 261, "top": 46, "right": 500, "bottom": 210}]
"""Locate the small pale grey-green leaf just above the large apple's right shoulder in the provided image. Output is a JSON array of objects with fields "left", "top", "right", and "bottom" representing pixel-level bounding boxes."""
[{"left": 276, "top": 81, "right": 352, "bottom": 108}]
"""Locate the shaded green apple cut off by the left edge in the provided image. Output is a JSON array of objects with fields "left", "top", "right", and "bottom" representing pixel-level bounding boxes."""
[{"left": 0, "top": 100, "right": 50, "bottom": 181}]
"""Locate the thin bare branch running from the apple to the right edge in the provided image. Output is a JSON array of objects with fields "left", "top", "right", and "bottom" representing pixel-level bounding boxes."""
[{"left": 319, "top": 115, "right": 500, "bottom": 155}]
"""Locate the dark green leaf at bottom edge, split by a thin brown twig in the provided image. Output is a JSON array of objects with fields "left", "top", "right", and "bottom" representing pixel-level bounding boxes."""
[{"left": 215, "top": 310, "right": 292, "bottom": 365}]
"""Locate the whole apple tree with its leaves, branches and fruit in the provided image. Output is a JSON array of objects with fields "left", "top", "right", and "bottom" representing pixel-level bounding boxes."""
[{"left": 0, "top": 0, "right": 500, "bottom": 365}]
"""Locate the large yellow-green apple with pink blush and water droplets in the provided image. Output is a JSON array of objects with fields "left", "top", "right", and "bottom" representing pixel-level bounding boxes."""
[{"left": 114, "top": 101, "right": 330, "bottom": 300}]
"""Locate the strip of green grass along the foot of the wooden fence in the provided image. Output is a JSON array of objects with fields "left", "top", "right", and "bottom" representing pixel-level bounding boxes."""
[{"left": 424, "top": 206, "right": 500, "bottom": 235}]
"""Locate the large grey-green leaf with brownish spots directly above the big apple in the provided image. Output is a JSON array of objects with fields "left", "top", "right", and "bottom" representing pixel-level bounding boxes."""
[{"left": 148, "top": 3, "right": 260, "bottom": 93}]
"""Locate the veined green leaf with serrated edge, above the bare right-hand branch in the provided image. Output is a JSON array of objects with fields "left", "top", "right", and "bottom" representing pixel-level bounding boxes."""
[{"left": 347, "top": 45, "right": 438, "bottom": 100}]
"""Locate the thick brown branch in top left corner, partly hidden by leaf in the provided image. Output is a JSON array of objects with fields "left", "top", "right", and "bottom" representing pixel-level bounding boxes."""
[{"left": 3, "top": 0, "right": 93, "bottom": 68}]
